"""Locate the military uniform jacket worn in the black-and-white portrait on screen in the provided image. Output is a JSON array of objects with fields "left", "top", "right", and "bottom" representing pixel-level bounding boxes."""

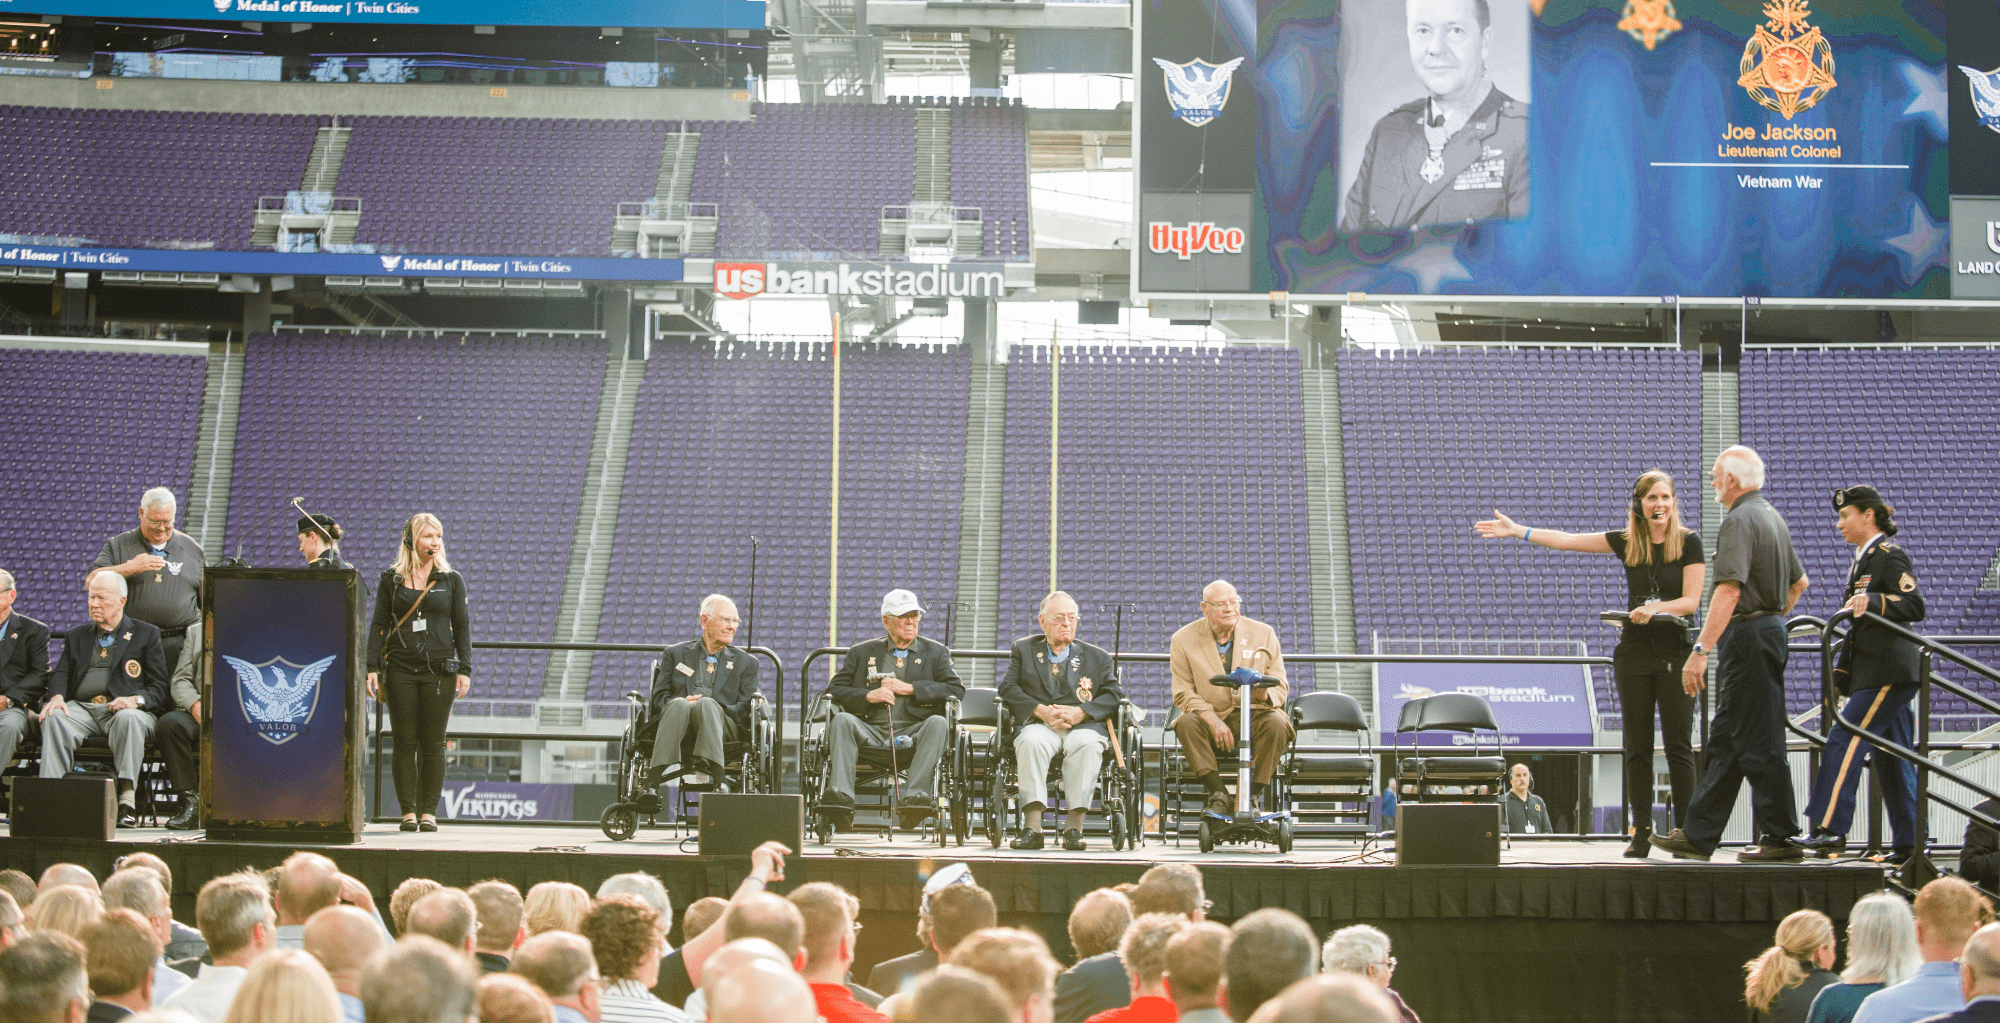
[{"left": 1340, "top": 88, "right": 1528, "bottom": 234}]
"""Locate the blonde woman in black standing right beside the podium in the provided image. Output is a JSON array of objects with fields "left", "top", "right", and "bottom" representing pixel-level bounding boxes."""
[{"left": 368, "top": 512, "right": 472, "bottom": 831}]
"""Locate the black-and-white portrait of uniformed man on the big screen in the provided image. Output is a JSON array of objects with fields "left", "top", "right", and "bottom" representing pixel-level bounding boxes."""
[{"left": 1340, "top": 0, "right": 1530, "bottom": 234}]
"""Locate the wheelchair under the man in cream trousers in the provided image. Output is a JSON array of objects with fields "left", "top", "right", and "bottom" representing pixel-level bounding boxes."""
[{"left": 968, "top": 691, "right": 1146, "bottom": 851}]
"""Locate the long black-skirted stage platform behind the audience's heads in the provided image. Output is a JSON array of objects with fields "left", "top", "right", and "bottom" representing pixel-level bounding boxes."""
[{"left": 0, "top": 821, "right": 1884, "bottom": 1023}]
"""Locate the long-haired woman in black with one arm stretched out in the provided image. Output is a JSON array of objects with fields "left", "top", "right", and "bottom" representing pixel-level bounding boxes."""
[{"left": 1472, "top": 470, "right": 1706, "bottom": 859}]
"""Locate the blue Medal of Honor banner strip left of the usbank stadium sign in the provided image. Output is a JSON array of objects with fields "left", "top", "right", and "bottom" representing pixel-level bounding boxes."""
[{"left": 0, "top": 243, "right": 682, "bottom": 282}]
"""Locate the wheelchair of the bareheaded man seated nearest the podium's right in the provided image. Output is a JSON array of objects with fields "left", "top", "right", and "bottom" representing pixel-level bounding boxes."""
[{"left": 598, "top": 661, "right": 778, "bottom": 841}]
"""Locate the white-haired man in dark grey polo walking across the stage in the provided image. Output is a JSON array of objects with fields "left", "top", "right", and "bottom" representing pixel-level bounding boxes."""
[{"left": 1652, "top": 446, "right": 1806, "bottom": 863}]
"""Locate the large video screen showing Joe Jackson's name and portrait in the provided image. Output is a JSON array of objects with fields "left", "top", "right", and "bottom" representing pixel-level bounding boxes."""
[{"left": 1132, "top": 0, "right": 1960, "bottom": 300}]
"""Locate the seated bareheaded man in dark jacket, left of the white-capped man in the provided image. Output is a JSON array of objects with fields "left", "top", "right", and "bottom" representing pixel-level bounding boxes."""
[{"left": 648, "top": 593, "right": 758, "bottom": 789}]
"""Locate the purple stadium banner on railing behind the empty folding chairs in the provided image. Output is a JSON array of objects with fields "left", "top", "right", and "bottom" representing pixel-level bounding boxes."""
[{"left": 1376, "top": 663, "right": 1596, "bottom": 749}]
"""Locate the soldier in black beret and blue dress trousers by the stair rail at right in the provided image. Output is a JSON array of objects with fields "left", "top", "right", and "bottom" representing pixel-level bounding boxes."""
[{"left": 1792, "top": 486, "right": 1924, "bottom": 863}]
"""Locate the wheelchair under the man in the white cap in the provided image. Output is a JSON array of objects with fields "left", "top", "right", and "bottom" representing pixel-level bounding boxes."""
[{"left": 798, "top": 691, "right": 966, "bottom": 847}]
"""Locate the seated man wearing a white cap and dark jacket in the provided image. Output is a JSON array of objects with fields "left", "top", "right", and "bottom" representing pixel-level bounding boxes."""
[{"left": 822, "top": 589, "right": 966, "bottom": 827}]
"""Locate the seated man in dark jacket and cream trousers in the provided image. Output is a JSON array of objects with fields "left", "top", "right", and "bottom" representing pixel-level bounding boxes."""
[{"left": 1000, "top": 589, "right": 1124, "bottom": 851}]
